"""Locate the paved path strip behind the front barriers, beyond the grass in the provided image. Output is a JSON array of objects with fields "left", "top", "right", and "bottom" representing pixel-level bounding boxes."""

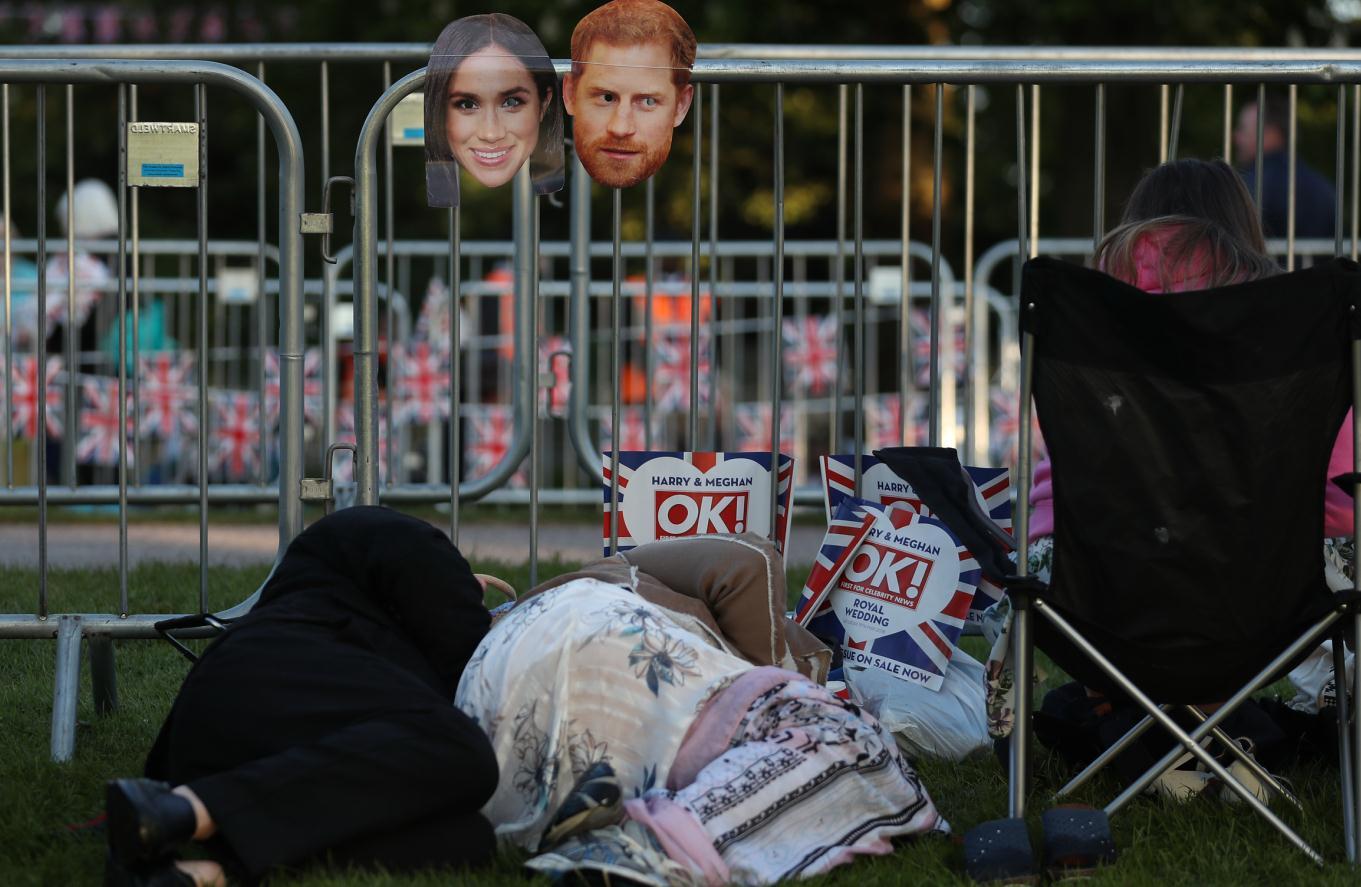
[{"left": 0, "top": 522, "right": 823, "bottom": 567}]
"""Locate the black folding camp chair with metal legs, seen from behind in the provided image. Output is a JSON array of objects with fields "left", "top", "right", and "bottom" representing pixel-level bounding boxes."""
[{"left": 1007, "top": 258, "right": 1361, "bottom": 863}]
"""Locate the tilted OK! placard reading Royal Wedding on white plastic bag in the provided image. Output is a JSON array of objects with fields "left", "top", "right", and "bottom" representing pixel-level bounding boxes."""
[{"left": 795, "top": 498, "right": 979, "bottom": 690}]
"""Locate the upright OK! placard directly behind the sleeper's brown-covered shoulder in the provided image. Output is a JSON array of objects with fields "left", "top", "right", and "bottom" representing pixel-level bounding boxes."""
[{"left": 602, "top": 452, "right": 793, "bottom": 556}]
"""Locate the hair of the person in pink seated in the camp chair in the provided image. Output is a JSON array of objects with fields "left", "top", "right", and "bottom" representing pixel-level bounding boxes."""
[{"left": 1094, "top": 159, "right": 1281, "bottom": 291}]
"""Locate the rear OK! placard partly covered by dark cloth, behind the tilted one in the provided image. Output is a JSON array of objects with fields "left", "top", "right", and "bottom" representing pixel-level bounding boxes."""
[{"left": 818, "top": 454, "right": 1011, "bottom": 623}]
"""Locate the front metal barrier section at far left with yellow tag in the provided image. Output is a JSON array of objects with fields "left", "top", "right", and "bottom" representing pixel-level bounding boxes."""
[{"left": 0, "top": 60, "right": 304, "bottom": 760}]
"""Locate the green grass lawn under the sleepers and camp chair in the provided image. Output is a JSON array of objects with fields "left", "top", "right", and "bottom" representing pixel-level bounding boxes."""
[{"left": 0, "top": 563, "right": 1357, "bottom": 887}]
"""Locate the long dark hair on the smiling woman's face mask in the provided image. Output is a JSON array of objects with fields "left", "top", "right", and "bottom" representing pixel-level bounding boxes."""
[{"left": 425, "top": 12, "right": 563, "bottom": 195}]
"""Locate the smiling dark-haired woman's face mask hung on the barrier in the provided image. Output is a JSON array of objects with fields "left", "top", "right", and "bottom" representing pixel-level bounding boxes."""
[{"left": 425, "top": 14, "right": 562, "bottom": 193}]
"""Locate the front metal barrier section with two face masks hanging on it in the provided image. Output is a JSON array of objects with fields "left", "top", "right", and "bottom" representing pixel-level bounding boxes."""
[{"left": 354, "top": 58, "right": 1361, "bottom": 595}]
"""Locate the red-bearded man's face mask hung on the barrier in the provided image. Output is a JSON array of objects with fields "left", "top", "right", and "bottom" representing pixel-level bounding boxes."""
[{"left": 562, "top": 0, "right": 695, "bottom": 188}]
